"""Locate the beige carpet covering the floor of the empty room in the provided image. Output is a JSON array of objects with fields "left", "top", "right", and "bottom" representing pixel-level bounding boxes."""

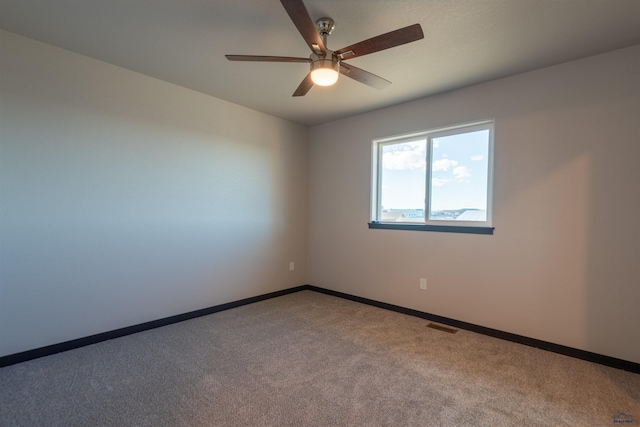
[{"left": 0, "top": 291, "right": 640, "bottom": 427}]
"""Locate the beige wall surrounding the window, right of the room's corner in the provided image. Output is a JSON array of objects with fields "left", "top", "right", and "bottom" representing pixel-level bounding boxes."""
[{"left": 309, "top": 46, "right": 640, "bottom": 362}]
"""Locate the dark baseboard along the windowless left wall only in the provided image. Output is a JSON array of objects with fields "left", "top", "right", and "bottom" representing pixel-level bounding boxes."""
[{"left": 0, "top": 285, "right": 309, "bottom": 368}]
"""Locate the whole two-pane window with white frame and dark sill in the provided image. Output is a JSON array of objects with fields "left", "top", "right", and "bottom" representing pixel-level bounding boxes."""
[{"left": 369, "top": 121, "right": 493, "bottom": 234}]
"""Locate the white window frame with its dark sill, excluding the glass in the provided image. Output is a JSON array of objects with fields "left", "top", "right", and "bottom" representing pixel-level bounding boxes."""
[{"left": 369, "top": 120, "right": 495, "bottom": 234}]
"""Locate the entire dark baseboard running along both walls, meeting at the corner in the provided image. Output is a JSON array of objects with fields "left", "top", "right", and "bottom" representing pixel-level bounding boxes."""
[{"left": 0, "top": 285, "right": 640, "bottom": 374}]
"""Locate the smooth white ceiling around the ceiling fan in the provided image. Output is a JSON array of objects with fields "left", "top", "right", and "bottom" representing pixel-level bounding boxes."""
[{"left": 0, "top": 0, "right": 640, "bottom": 125}]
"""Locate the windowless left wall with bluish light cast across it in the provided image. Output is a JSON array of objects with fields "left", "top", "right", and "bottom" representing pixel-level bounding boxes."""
[{"left": 0, "top": 32, "right": 308, "bottom": 356}]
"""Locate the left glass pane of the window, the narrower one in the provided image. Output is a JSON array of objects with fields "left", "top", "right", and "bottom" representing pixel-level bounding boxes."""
[{"left": 380, "top": 139, "right": 427, "bottom": 222}]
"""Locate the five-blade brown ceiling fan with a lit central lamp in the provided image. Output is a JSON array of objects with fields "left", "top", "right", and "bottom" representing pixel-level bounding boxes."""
[{"left": 225, "top": 0, "right": 424, "bottom": 96}]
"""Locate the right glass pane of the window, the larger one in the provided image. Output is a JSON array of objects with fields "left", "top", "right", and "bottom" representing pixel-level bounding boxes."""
[{"left": 429, "top": 129, "right": 489, "bottom": 221}]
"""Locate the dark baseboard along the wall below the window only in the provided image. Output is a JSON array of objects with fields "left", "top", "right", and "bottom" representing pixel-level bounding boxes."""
[{"left": 307, "top": 285, "right": 640, "bottom": 374}]
